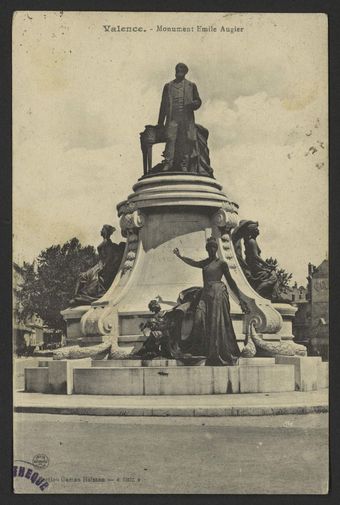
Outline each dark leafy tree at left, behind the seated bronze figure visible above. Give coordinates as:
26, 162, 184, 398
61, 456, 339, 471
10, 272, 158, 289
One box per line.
14, 238, 98, 333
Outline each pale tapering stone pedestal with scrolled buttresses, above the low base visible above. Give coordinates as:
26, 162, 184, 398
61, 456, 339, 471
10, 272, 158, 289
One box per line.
62, 173, 284, 352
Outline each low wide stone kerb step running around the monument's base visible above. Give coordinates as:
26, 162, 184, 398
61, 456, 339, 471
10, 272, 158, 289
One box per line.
14, 389, 328, 417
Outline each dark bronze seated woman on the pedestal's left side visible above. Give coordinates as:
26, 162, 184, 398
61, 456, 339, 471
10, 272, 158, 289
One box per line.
70, 224, 125, 306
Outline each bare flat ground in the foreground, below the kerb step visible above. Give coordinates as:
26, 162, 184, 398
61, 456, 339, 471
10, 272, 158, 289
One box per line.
14, 414, 328, 494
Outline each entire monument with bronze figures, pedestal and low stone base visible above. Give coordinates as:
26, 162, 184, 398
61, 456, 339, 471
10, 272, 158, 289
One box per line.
25, 64, 327, 395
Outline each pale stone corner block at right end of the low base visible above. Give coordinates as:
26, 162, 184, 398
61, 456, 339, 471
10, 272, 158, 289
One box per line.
275, 356, 322, 391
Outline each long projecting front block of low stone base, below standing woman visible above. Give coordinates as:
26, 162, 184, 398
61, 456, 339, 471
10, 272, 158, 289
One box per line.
74, 364, 295, 395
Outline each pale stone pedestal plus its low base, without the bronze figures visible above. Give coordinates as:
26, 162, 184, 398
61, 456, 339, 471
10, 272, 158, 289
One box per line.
20, 173, 308, 395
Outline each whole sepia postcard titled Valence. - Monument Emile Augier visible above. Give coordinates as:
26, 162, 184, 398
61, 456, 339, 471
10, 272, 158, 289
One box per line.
13, 11, 329, 495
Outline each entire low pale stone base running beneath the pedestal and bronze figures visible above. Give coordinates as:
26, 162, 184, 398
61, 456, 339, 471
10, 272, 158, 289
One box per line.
25, 356, 328, 396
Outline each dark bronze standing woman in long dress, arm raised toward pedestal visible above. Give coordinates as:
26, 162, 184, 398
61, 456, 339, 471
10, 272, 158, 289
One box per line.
174, 237, 248, 365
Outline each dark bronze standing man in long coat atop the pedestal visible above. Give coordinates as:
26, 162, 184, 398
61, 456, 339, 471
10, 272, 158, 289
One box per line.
158, 63, 202, 172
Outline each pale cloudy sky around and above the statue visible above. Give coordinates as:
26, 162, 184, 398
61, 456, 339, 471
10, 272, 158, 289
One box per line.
13, 12, 328, 284
